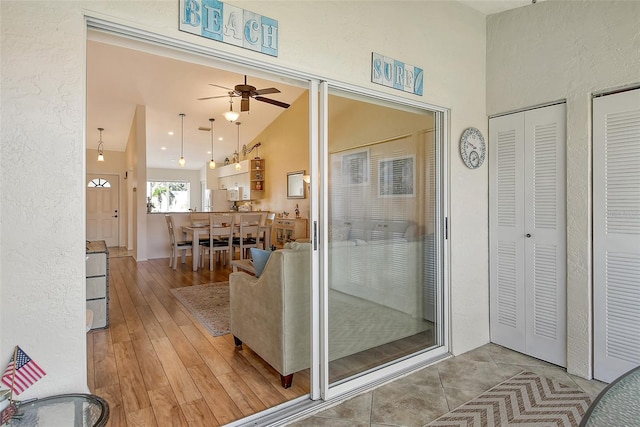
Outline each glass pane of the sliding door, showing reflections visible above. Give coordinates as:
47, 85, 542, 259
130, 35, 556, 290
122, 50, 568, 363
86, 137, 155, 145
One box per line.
325, 90, 443, 386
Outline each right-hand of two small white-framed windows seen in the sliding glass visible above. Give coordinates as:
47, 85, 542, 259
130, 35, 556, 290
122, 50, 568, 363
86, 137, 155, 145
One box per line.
378, 155, 416, 197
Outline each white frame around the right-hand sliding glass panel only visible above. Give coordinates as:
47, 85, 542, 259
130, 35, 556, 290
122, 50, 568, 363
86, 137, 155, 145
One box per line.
312, 81, 450, 400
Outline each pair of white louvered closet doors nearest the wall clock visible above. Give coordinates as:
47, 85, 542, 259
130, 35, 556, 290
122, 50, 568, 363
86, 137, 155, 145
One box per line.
489, 104, 566, 366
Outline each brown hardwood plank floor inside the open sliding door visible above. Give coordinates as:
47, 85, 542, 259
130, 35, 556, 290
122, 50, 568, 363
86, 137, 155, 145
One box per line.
87, 257, 309, 426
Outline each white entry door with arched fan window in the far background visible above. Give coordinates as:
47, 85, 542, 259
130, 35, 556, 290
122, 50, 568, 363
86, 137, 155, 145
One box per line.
87, 174, 120, 247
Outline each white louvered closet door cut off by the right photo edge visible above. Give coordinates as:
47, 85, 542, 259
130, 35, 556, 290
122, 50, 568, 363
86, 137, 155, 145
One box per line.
593, 89, 640, 382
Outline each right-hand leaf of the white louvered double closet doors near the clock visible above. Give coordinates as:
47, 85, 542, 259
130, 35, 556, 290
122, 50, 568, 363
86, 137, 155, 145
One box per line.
524, 104, 567, 366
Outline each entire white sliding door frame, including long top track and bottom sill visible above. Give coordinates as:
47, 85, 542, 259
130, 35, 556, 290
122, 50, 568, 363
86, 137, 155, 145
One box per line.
85, 14, 450, 425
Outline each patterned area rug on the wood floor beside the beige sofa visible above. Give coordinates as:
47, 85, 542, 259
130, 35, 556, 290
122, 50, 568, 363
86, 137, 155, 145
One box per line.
171, 282, 229, 337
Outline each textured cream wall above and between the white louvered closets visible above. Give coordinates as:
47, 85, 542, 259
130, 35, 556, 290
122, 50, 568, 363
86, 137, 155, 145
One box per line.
487, 0, 640, 378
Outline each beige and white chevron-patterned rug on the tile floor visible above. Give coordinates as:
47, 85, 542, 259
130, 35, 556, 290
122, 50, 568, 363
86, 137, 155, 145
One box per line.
427, 371, 591, 427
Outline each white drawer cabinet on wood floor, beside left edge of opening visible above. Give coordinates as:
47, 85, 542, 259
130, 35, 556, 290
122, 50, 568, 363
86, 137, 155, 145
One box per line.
86, 240, 109, 329
